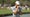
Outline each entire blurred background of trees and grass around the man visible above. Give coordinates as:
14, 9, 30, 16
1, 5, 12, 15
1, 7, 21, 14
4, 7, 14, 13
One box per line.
0, 0, 30, 16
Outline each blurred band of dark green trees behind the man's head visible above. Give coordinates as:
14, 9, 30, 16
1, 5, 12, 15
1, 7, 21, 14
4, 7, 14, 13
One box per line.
0, 0, 30, 6
